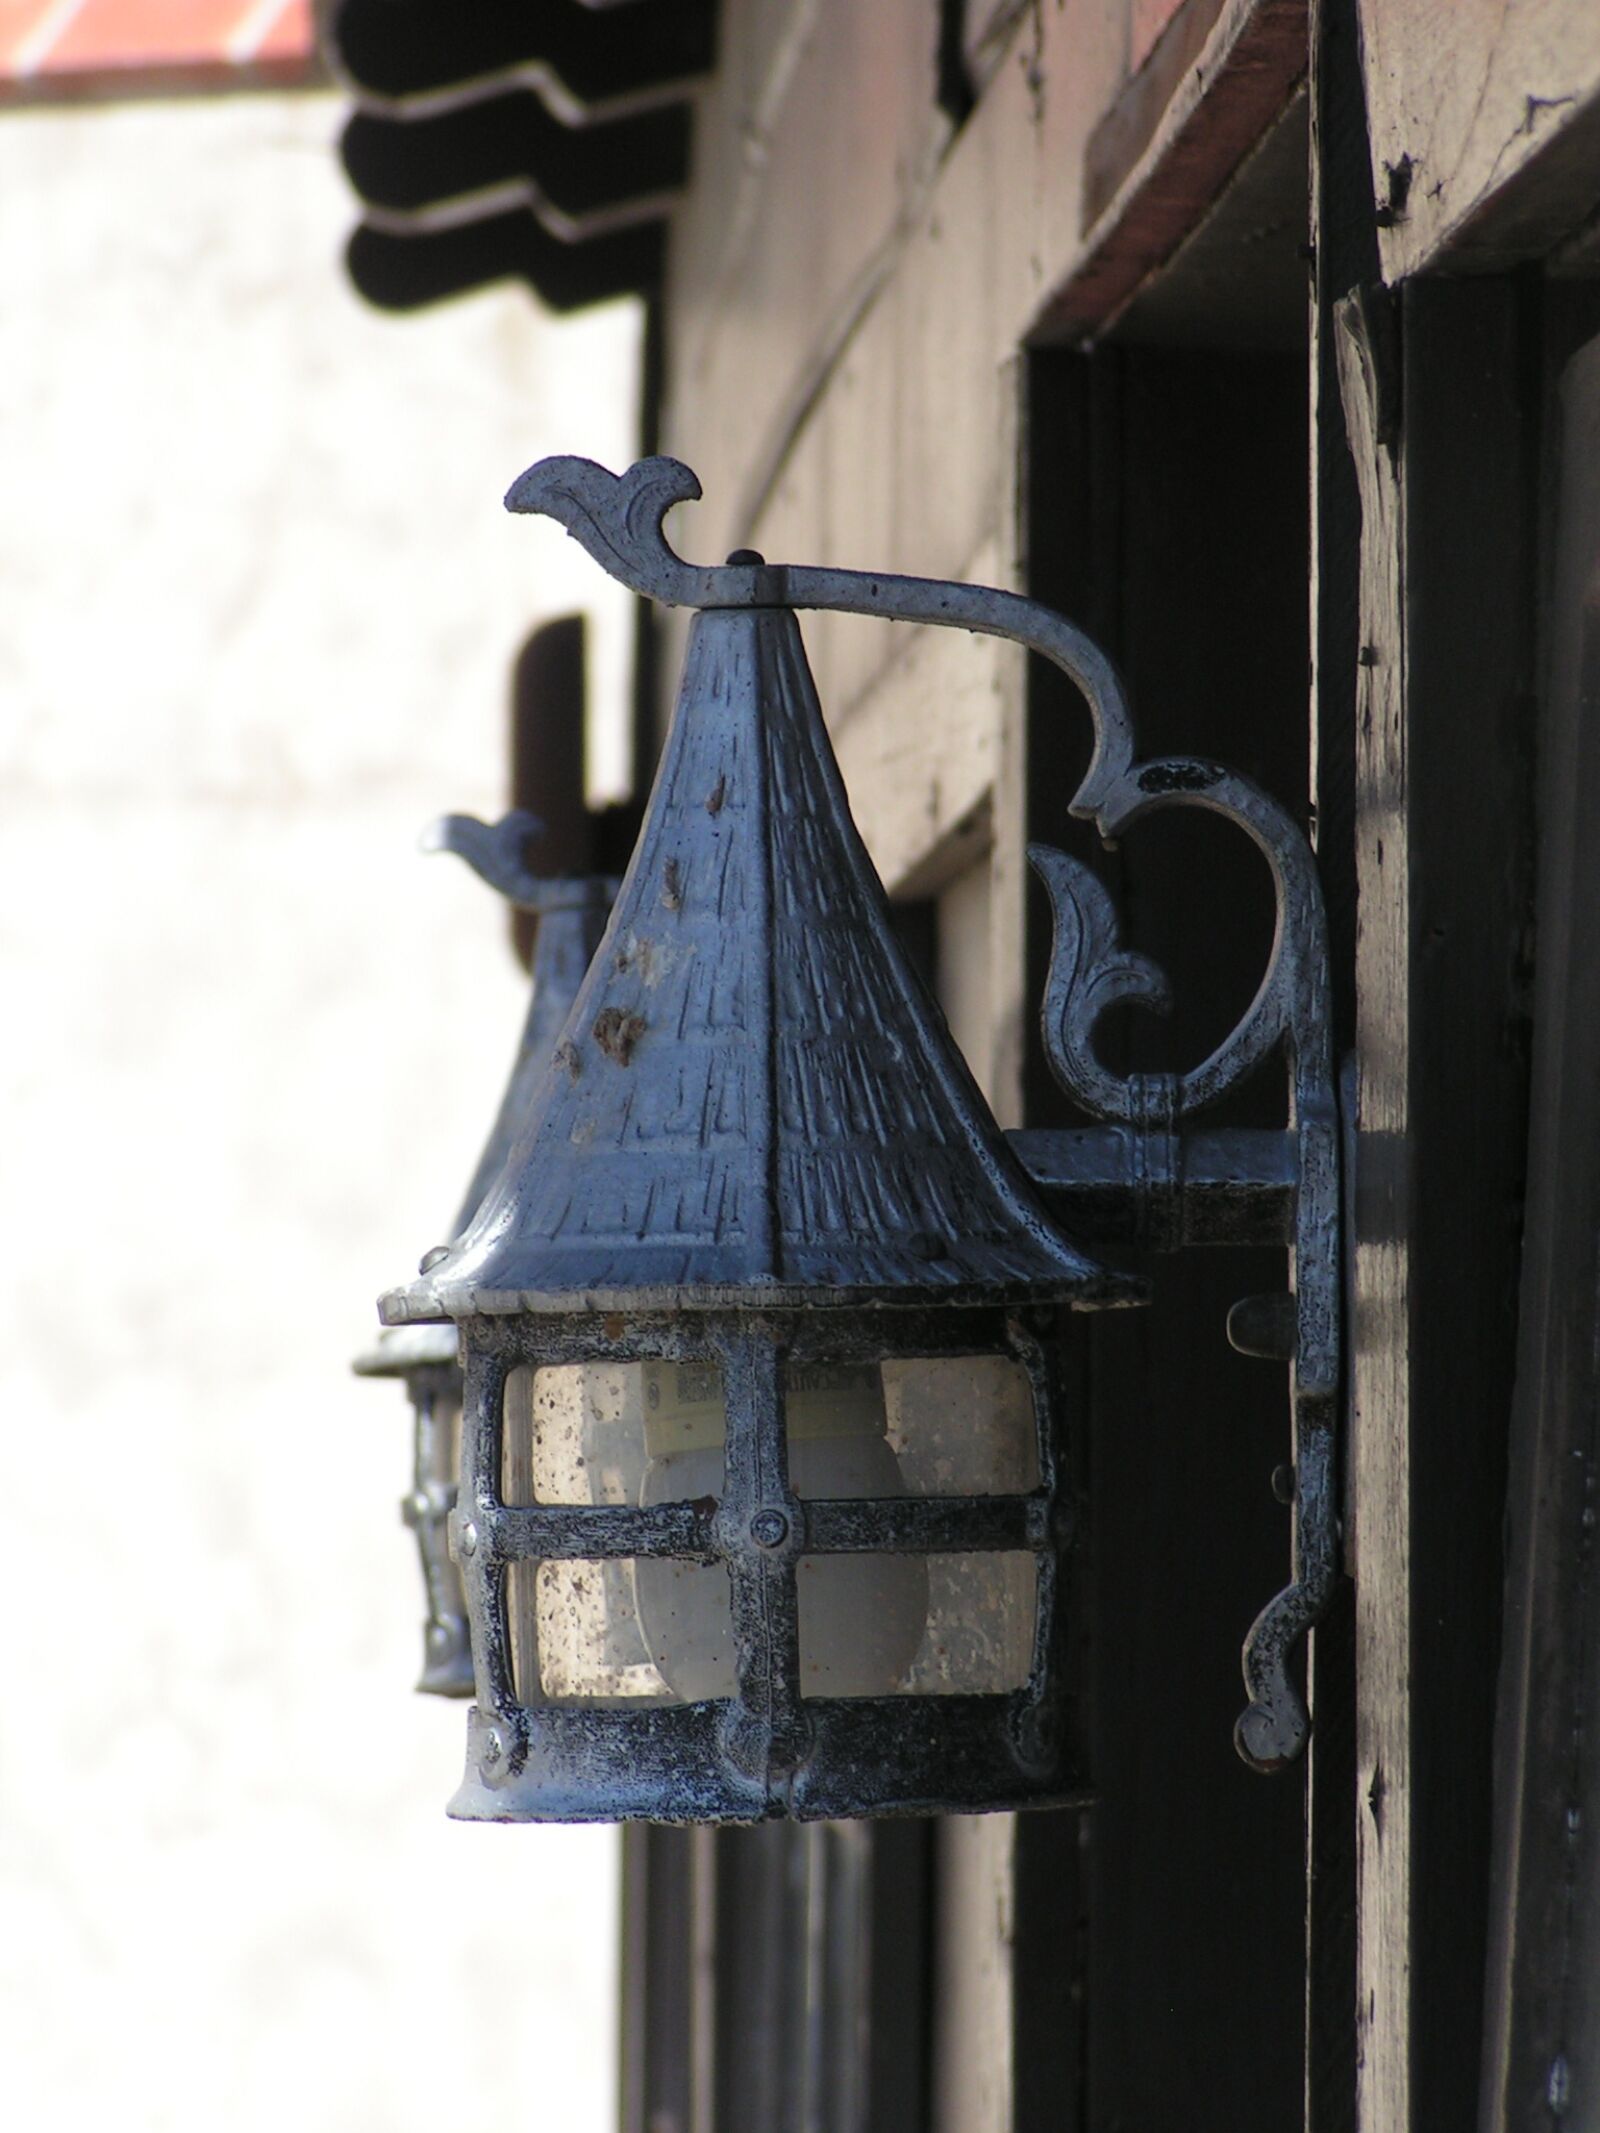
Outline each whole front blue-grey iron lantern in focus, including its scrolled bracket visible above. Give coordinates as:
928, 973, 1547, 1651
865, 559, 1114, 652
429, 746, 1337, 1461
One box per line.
382, 459, 1340, 1822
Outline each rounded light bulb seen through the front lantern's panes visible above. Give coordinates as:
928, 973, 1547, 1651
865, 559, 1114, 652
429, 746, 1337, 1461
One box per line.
634, 1363, 928, 1702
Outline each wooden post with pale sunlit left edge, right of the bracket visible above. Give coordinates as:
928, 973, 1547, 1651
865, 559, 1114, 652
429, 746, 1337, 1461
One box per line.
1342, 279, 1538, 2133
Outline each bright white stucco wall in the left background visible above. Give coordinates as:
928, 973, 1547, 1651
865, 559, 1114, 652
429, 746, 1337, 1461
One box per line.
0, 96, 634, 2133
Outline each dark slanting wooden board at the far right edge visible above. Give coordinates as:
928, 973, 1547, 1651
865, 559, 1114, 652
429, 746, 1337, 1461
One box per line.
1483, 324, 1600, 2133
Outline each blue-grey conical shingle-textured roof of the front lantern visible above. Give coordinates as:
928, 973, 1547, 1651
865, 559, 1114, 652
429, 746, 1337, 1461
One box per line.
382, 588, 1135, 1325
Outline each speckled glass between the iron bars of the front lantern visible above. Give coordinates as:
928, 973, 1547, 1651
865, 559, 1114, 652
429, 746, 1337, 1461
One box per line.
501, 1354, 1039, 1702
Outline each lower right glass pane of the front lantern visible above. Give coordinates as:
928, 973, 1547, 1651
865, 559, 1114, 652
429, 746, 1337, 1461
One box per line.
798, 1549, 1039, 1696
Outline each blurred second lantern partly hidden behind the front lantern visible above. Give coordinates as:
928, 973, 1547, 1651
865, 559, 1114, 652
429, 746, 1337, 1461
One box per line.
352, 808, 617, 1696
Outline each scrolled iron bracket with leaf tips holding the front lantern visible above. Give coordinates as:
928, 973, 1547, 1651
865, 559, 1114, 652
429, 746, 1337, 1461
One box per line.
506, 459, 1342, 1770
